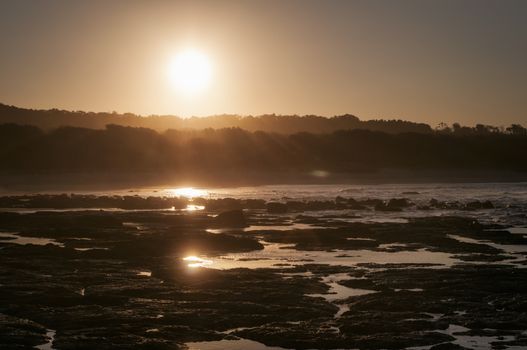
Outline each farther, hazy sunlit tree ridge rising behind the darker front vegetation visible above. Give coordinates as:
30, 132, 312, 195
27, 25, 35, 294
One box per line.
0, 104, 433, 134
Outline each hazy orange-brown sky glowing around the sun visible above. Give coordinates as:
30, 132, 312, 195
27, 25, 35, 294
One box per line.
0, 0, 527, 125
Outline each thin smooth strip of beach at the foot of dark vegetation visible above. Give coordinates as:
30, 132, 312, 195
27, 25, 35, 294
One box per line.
0, 169, 527, 194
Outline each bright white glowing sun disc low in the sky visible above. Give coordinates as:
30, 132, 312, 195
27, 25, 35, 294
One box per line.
168, 49, 212, 95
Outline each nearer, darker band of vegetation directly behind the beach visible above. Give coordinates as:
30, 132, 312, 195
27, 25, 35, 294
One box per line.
0, 124, 527, 174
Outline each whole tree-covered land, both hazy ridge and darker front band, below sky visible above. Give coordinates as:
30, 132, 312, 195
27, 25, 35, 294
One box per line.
0, 104, 527, 178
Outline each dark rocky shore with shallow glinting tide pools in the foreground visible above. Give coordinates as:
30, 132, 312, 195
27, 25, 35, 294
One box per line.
0, 195, 527, 350
